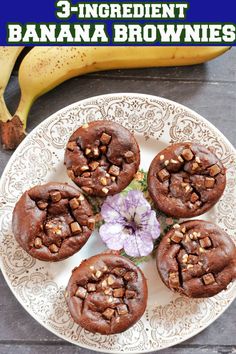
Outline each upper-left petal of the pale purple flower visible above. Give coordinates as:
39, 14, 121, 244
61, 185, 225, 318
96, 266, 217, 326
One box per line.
101, 194, 124, 223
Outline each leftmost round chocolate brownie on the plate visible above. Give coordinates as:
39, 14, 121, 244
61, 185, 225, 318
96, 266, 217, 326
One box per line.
12, 183, 95, 261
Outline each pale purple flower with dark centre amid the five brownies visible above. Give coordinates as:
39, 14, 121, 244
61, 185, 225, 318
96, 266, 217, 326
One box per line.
99, 190, 160, 257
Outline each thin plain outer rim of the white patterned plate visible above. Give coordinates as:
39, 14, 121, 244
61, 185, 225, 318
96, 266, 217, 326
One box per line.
0, 92, 236, 353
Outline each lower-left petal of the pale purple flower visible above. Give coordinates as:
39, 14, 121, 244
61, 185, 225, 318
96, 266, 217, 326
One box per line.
99, 223, 126, 251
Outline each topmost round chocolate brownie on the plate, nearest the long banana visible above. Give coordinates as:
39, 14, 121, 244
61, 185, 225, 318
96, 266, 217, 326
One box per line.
65, 120, 140, 197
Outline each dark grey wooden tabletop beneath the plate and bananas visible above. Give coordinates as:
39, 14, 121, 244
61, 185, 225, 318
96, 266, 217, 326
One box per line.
0, 48, 236, 354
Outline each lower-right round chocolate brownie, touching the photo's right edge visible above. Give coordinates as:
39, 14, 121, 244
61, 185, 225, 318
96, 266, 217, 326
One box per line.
156, 220, 236, 298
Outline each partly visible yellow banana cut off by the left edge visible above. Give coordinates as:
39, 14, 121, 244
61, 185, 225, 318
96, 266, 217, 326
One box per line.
0, 46, 24, 148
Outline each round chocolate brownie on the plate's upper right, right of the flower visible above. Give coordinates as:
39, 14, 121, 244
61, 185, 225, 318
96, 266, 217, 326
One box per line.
148, 142, 226, 218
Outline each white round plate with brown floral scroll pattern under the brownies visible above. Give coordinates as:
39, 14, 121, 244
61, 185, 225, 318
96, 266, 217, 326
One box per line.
0, 94, 236, 353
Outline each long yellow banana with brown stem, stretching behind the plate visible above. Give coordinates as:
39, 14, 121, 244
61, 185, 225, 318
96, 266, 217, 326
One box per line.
0, 46, 229, 149
